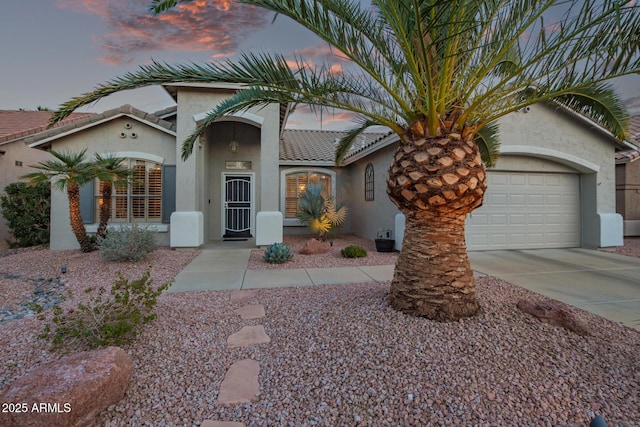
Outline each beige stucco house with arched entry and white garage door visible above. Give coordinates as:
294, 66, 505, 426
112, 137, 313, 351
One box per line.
17, 83, 632, 250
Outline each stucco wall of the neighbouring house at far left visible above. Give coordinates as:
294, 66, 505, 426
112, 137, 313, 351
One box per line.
0, 141, 49, 249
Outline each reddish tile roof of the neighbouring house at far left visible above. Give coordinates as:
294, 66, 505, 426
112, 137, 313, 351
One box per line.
0, 110, 94, 144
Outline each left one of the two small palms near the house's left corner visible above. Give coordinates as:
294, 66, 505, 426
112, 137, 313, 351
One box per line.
22, 149, 95, 252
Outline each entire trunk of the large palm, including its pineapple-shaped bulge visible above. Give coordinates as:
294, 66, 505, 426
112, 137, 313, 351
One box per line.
387, 132, 486, 321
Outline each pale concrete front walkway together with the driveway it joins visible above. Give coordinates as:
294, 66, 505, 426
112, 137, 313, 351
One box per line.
169, 245, 640, 329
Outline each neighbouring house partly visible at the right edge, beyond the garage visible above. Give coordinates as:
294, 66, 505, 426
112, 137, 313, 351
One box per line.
616, 116, 640, 236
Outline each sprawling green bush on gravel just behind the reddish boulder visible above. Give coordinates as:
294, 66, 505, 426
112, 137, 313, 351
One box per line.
39, 269, 172, 350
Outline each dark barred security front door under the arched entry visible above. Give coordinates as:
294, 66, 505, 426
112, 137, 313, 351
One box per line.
222, 173, 253, 239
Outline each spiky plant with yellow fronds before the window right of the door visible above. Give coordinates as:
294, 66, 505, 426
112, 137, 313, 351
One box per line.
296, 183, 347, 240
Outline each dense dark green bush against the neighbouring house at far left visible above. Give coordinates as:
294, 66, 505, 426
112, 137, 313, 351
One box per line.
0, 182, 51, 248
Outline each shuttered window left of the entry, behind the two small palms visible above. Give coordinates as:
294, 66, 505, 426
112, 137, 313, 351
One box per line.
94, 159, 162, 222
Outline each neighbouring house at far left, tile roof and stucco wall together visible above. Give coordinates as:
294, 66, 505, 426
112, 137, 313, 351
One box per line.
0, 110, 91, 249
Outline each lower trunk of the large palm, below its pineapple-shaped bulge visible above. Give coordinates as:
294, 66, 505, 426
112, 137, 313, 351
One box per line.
390, 212, 479, 321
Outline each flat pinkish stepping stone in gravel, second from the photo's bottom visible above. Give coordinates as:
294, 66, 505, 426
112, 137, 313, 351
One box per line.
216, 359, 260, 406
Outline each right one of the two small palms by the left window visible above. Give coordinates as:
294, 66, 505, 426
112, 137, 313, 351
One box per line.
93, 154, 131, 238
